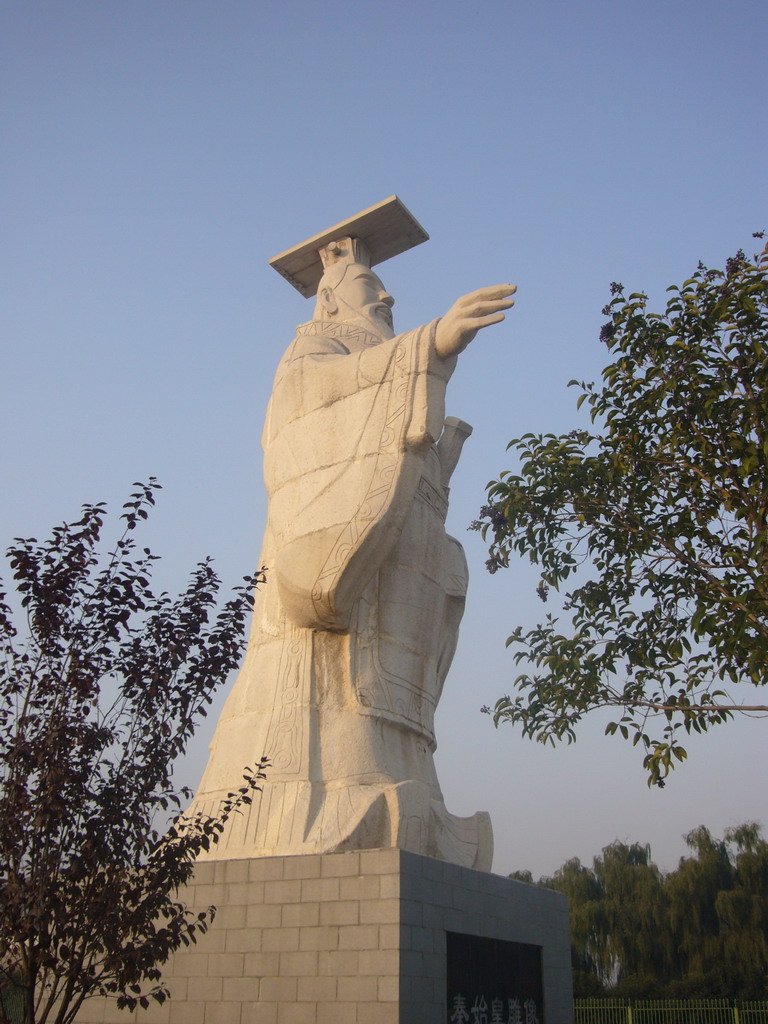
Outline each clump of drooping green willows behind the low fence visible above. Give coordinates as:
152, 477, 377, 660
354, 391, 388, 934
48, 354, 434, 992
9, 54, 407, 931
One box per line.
515, 823, 768, 999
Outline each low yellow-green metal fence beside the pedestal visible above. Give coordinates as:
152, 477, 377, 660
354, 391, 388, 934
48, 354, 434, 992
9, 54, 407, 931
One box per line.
573, 999, 768, 1024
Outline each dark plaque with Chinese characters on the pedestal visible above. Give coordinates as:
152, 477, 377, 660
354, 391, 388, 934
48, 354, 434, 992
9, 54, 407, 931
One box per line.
446, 932, 544, 1024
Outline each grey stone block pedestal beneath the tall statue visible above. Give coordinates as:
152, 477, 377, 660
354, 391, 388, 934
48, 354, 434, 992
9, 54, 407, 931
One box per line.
78, 849, 572, 1024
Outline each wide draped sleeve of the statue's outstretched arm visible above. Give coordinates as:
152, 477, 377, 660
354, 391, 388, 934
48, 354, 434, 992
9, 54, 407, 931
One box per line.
263, 322, 456, 632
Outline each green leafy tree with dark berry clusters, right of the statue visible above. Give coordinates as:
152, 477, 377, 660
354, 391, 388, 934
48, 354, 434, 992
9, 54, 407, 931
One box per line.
473, 236, 768, 785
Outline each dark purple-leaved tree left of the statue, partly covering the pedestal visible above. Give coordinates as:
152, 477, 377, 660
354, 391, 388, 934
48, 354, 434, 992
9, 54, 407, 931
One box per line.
0, 479, 263, 1024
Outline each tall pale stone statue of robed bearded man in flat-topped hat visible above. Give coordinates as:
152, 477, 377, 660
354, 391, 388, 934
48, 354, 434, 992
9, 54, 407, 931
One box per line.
191, 197, 515, 870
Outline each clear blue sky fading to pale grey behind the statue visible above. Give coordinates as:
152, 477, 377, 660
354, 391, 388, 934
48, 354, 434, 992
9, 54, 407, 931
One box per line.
0, 0, 768, 874
